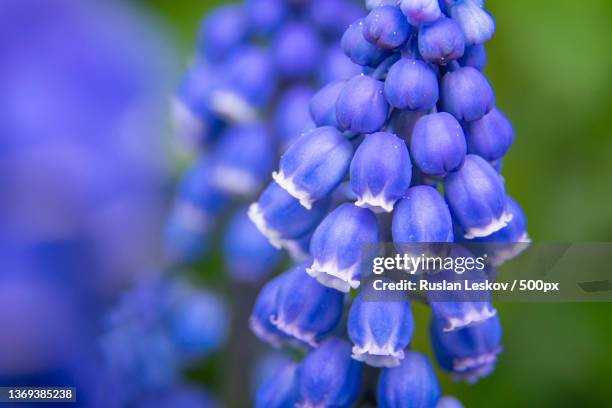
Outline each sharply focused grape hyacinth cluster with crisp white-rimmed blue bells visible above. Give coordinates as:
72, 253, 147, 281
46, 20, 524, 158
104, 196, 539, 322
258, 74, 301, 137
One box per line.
249, 0, 528, 407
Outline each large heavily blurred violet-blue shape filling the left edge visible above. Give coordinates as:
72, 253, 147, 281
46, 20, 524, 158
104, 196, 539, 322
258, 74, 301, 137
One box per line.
0, 0, 168, 407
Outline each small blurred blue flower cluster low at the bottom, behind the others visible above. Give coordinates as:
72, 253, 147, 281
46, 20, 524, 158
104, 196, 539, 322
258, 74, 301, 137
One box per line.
99, 277, 229, 407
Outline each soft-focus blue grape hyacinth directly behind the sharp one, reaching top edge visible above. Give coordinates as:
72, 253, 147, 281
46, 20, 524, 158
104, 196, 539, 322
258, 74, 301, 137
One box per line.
165, 0, 365, 283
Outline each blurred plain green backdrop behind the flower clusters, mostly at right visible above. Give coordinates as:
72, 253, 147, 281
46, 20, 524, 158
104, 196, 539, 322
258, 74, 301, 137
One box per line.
144, 0, 612, 407
